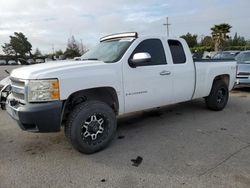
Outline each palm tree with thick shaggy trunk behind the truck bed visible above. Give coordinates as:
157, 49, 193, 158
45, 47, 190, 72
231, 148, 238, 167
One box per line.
211, 23, 232, 51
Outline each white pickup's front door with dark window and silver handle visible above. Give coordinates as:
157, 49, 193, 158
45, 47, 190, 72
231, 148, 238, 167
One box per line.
123, 38, 173, 112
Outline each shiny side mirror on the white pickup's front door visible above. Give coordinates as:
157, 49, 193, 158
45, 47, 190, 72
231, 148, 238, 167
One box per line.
129, 52, 151, 68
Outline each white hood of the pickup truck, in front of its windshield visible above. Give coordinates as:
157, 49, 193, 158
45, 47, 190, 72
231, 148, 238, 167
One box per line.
11, 60, 106, 79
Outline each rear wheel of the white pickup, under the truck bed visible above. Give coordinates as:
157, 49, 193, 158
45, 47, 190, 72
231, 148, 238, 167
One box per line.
205, 80, 229, 111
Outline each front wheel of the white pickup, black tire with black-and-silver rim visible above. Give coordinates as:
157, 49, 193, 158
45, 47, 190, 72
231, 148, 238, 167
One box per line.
65, 101, 117, 154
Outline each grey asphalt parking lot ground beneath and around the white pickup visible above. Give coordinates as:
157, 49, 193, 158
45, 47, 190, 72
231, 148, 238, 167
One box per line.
0, 90, 250, 188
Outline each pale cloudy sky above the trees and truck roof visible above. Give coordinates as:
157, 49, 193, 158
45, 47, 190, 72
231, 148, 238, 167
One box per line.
0, 0, 250, 53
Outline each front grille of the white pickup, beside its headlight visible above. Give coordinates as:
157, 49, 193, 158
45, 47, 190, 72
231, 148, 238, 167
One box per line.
10, 78, 25, 103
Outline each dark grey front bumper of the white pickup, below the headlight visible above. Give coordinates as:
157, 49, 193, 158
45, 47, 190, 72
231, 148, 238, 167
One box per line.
6, 97, 63, 133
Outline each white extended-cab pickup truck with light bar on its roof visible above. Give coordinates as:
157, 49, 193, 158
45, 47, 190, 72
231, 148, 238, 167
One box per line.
1, 33, 236, 153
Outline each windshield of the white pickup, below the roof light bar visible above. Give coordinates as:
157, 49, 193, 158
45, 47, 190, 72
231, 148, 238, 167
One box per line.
81, 38, 134, 63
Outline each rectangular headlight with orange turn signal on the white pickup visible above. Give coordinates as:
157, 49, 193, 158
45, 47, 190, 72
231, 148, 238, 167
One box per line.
28, 79, 60, 102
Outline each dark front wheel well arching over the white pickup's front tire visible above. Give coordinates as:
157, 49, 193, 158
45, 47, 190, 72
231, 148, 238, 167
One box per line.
62, 87, 119, 120
